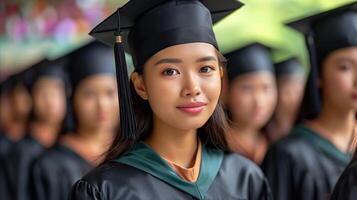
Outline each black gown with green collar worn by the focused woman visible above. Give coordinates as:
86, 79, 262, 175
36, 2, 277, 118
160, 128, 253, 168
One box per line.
70, 142, 271, 200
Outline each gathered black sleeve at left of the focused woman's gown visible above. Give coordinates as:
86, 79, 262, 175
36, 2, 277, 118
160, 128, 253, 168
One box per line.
69, 180, 105, 200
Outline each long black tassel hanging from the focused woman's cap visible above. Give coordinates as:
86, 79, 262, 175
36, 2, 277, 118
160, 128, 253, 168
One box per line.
114, 10, 137, 142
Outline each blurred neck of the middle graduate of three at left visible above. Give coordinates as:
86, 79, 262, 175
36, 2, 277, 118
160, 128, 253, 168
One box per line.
30, 121, 60, 147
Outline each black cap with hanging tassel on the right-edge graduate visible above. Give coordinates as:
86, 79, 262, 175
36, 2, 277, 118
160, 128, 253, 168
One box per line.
287, 1, 357, 119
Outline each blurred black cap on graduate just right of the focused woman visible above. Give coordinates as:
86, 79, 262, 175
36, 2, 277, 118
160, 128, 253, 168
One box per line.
225, 43, 274, 81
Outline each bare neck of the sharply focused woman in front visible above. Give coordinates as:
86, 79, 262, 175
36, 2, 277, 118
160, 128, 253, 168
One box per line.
145, 116, 198, 167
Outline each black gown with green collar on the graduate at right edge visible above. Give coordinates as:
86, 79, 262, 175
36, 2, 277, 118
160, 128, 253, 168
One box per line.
262, 125, 351, 200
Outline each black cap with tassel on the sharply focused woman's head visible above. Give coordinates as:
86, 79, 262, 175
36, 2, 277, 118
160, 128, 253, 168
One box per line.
90, 0, 242, 142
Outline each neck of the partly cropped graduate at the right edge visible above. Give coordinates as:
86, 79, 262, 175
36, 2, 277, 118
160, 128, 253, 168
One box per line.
310, 101, 355, 152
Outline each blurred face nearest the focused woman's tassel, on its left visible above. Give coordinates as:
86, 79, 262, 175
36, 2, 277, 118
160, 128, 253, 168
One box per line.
73, 74, 119, 131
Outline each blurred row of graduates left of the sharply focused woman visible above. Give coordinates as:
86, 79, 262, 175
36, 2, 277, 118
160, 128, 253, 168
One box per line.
0, 42, 119, 200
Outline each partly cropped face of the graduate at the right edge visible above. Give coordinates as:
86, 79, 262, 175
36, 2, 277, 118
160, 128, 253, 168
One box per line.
320, 47, 357, 110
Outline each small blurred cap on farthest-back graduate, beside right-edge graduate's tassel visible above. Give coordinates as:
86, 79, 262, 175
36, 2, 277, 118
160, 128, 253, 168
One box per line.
275, 57, 303, 78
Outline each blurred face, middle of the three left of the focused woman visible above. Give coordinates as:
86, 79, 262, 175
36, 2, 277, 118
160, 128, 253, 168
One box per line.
32, 77, 66, 124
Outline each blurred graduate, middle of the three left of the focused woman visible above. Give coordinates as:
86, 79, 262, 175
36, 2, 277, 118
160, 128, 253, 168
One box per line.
6, 60, 66, 199
